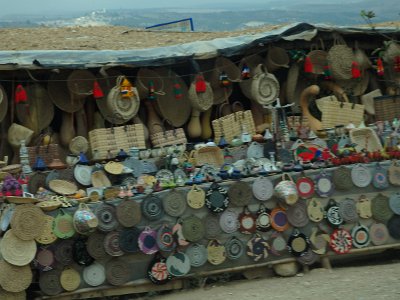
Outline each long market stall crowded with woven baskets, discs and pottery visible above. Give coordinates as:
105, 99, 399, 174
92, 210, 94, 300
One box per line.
0, 24, 400, 299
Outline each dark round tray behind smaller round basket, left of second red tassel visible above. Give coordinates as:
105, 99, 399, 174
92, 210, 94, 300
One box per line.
47, 72, 86, 113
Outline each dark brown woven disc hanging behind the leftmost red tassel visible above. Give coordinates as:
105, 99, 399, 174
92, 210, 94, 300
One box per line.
15, 84, 54, 134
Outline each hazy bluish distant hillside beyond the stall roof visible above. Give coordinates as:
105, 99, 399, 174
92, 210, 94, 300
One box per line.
0, 0, 400, 31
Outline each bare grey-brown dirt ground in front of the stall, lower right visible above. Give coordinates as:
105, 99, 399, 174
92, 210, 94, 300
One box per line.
151, 255, 400, 300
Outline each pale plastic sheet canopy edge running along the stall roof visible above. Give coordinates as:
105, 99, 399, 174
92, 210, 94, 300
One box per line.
0, 23, 399, 70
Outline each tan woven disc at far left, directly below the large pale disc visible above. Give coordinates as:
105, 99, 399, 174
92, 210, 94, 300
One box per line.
0, 260, 33, 293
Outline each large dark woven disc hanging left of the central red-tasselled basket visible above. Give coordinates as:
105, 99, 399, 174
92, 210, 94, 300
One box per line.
152, 68, 192, 127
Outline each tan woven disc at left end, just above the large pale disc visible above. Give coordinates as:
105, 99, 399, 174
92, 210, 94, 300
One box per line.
11, 204, 45, 240
